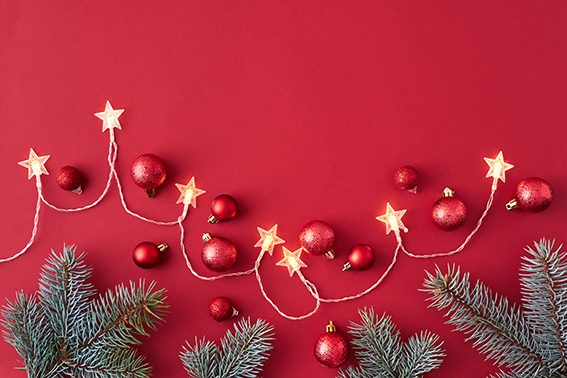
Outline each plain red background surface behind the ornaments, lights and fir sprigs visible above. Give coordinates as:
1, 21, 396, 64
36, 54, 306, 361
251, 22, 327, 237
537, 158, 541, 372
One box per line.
0, 1, 567, 378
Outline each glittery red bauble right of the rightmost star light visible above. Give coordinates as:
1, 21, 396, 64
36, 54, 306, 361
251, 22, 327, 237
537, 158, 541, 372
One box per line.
506, 177, 553, 213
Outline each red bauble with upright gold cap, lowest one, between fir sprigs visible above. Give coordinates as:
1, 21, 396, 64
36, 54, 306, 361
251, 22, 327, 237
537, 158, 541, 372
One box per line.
315, 322, 348, 368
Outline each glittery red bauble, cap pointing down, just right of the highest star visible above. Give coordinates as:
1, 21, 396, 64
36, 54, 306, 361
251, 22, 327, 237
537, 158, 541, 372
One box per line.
130, 154, 167, 198
